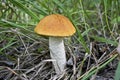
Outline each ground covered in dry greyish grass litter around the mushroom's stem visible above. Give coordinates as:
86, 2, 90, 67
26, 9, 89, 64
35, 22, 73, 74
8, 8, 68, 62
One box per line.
0, 28, 118, 80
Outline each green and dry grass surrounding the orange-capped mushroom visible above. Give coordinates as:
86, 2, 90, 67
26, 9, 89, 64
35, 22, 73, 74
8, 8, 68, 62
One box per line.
0, 0, 120, 80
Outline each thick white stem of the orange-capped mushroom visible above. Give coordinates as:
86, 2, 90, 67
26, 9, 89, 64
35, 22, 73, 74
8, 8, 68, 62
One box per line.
49, 37, 66, 74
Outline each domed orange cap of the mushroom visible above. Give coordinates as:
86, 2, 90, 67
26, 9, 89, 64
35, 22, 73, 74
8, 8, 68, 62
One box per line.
34, 14, 76, 37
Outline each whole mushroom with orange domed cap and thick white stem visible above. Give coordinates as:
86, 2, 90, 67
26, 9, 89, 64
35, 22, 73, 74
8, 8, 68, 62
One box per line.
34, 14, 76, 74
